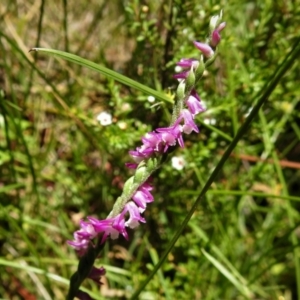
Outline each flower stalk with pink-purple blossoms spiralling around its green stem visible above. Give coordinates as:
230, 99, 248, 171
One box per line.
68, 13, 225, 299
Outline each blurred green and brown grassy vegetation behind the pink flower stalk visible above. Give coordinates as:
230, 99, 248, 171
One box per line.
0, 0, 300, 300
